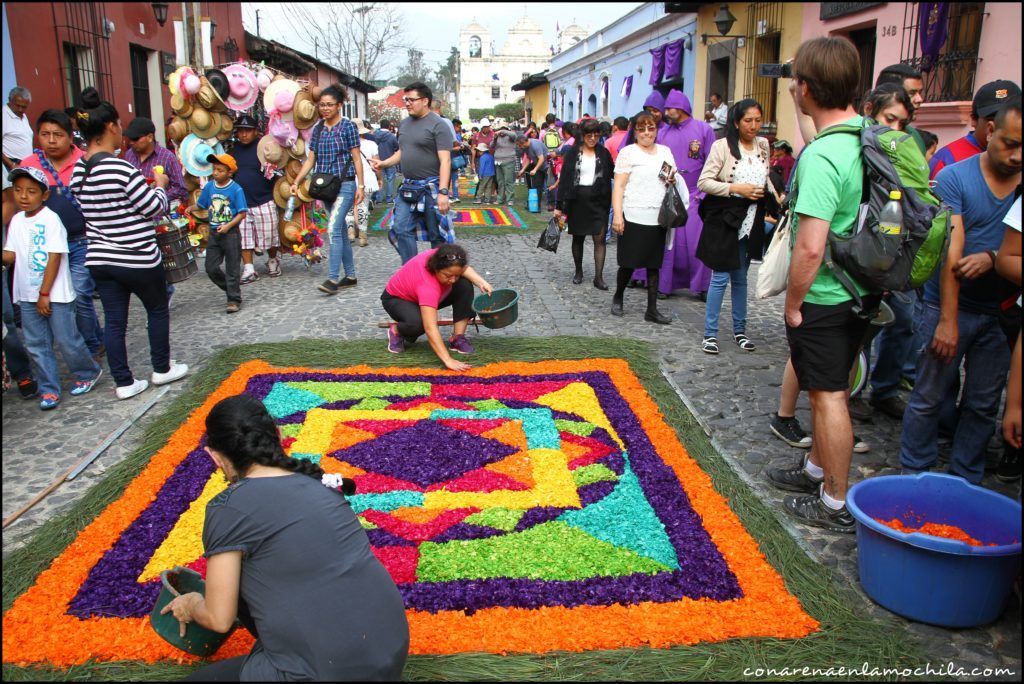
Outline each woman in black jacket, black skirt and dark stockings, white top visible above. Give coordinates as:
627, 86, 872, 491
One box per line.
555, 119, 614, 290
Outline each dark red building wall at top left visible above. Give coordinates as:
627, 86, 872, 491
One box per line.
5, 2, 248, 128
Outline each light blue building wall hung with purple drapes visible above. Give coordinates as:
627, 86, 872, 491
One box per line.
548, 2, 697, 121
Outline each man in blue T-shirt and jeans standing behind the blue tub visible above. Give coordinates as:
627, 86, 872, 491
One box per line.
900, 97, 1021, 484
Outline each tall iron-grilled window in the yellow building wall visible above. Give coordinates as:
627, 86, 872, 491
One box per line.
745, 2, 783, 135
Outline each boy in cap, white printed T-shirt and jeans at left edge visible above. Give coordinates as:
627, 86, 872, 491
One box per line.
3, 167, 102, 411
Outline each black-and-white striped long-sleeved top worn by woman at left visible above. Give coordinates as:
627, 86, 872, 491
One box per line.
71, 157, 168, 268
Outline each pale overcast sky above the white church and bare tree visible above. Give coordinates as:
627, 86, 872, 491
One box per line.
242, 2, 642, 76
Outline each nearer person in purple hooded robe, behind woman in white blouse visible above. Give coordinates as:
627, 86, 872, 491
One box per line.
656, 90, 715, 299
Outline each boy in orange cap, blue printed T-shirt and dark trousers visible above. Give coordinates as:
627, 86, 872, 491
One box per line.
188, 155, 249, 313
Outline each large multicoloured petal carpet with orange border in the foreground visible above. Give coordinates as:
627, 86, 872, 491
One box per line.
3, 359, 817, 667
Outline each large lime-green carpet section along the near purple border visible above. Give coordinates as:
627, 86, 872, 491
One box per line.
416, 520, 669, 583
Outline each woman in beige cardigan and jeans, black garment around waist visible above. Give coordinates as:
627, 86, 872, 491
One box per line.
696, 99, 778, 354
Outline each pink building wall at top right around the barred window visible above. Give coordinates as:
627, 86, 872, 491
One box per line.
794, 2, 1021, 152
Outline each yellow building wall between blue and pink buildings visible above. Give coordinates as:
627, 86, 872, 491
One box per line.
693, 2, 802, 148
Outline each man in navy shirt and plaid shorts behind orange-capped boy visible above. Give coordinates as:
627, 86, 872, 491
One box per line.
231, 114, 281, 285
